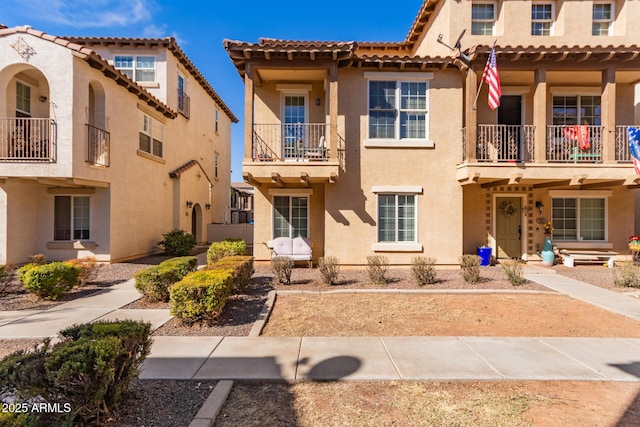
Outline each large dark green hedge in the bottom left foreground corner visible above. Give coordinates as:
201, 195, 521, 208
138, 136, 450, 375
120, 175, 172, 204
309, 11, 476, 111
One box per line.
0, 321, 151, 426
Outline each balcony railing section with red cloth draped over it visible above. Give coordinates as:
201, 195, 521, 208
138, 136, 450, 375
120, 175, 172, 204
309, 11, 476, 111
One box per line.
547, 125, 602, 163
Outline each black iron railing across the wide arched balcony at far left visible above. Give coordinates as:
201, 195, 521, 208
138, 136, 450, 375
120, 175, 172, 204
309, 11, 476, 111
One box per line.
0, 117, 57, 162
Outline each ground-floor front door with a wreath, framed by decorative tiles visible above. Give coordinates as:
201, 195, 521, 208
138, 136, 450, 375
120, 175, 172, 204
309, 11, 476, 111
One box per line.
496, 197, 522, 258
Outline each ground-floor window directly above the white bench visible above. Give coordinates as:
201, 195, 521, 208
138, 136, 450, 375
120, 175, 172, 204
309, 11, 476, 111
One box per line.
273, 196, 309, 239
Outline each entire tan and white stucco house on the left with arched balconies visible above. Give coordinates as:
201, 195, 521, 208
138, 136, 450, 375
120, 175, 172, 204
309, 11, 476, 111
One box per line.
0, 27, 237, 264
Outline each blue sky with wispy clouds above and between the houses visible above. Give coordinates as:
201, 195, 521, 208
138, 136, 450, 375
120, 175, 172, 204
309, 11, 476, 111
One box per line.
0, 0, 422, 181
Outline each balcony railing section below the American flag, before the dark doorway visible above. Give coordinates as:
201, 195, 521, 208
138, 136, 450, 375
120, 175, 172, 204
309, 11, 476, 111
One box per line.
476, 125, 535, 163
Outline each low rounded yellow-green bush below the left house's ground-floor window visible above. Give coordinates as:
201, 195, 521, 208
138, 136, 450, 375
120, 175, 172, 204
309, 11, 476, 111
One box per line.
19, 262, 81, 300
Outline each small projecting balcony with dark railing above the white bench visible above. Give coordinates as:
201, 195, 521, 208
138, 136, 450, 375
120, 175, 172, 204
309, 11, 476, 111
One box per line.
243, 123, 344, 185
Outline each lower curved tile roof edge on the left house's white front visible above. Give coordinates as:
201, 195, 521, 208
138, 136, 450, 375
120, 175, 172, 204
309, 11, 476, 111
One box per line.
0, 26, 177, 118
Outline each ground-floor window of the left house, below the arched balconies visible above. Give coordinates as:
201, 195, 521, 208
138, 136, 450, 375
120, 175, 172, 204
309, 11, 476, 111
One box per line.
53, 196, 91, 240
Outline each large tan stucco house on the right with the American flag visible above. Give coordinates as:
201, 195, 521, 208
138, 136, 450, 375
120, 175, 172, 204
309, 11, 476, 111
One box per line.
224, 0, 640, 264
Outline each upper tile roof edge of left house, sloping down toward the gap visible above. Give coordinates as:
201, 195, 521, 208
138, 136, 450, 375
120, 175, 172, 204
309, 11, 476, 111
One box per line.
66, 37, 238, 123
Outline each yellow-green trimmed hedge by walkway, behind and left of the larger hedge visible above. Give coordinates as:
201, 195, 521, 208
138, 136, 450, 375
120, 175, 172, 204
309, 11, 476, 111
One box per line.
133, 256, 198, 302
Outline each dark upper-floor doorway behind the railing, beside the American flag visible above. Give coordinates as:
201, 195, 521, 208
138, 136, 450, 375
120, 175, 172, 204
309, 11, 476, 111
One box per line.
496, 95, 523, 162
